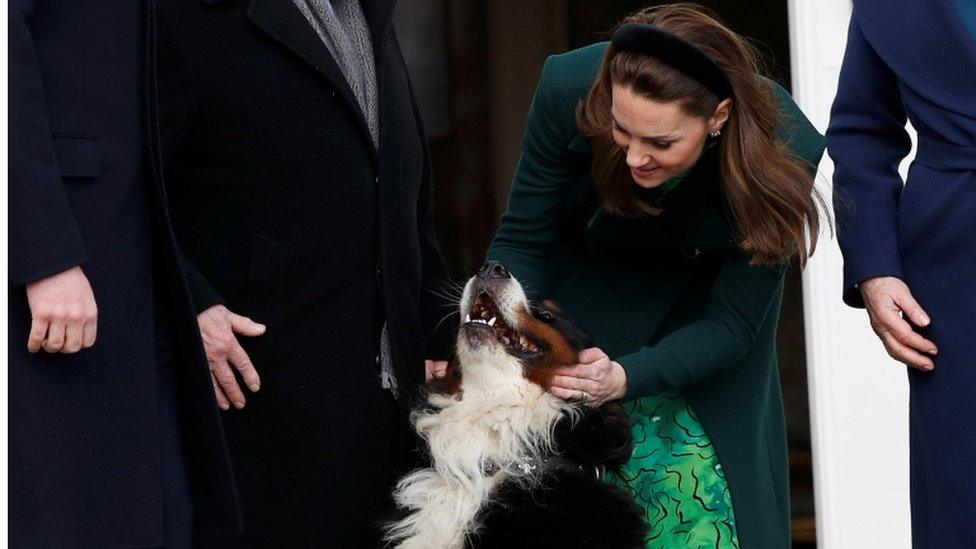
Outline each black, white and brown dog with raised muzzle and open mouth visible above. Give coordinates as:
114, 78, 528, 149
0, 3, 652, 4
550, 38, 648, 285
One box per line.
386, 262, 647, 549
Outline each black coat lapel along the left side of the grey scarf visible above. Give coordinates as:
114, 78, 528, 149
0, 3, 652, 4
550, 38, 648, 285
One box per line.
247, 0, 380, 152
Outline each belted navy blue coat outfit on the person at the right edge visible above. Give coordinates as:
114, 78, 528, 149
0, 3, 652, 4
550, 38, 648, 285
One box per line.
827, 0, 976, 549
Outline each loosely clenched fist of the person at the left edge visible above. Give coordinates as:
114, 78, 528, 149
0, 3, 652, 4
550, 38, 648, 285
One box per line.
27, 267, 98, 354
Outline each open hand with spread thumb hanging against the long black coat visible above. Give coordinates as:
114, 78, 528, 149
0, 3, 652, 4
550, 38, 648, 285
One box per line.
197, 305, 265, 410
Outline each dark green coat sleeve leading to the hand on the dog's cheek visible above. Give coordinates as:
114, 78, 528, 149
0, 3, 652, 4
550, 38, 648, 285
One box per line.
617, 252, 787, 399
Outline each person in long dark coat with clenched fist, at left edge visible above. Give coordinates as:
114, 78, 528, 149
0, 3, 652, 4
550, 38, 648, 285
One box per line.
8, 0, 240, 549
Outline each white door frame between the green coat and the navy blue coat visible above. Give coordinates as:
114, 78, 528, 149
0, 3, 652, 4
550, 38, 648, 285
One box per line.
788, 0, 911, 549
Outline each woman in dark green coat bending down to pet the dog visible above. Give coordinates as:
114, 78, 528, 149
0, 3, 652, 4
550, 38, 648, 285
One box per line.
488, 4, 824, 549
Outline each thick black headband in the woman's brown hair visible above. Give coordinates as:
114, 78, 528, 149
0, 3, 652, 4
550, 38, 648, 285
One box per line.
611, 23, 732, 99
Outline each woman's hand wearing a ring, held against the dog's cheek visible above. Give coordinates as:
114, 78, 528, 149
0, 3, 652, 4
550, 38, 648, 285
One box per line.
550, 347, 627, 407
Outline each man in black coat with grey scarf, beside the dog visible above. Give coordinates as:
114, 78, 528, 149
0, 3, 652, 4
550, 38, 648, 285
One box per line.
159, 0, 451, 547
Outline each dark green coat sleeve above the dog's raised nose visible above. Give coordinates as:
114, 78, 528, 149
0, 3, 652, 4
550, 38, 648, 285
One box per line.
487, 57, 575, 299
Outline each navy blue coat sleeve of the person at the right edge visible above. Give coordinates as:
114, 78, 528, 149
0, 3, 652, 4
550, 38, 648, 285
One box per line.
827, 14, 911, 307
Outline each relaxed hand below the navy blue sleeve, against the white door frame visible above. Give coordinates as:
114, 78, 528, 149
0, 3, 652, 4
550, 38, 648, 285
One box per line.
858, 276, 938, 372
